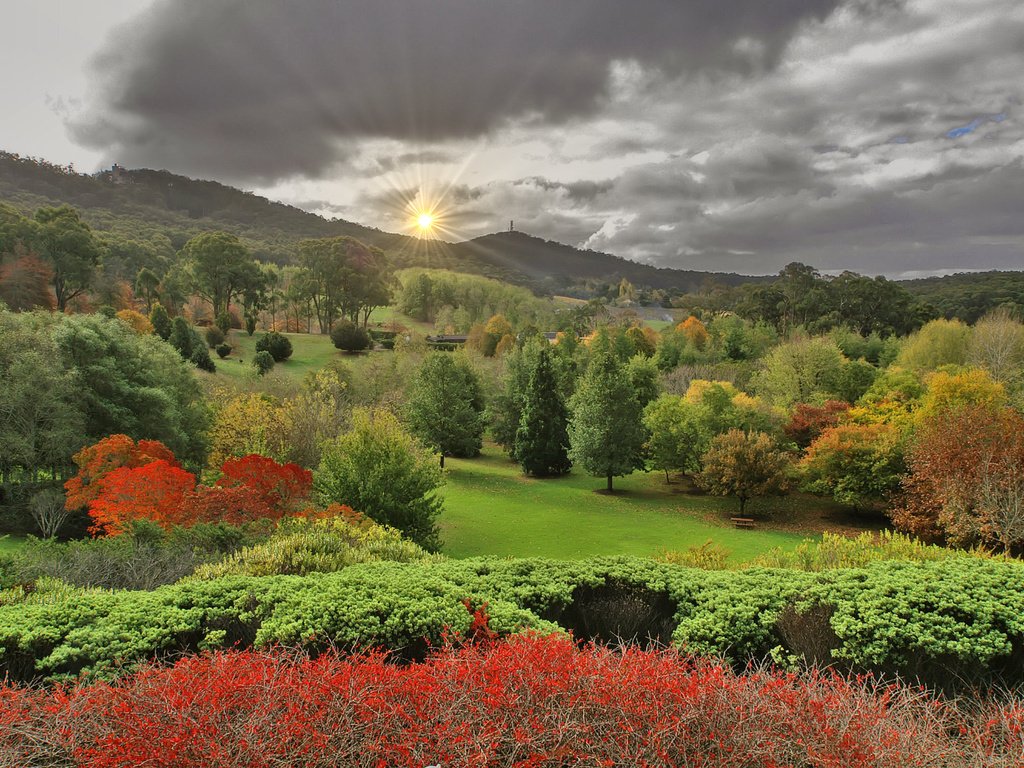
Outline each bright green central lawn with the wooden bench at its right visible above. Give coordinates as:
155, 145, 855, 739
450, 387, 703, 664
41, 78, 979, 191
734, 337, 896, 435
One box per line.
440, 446, 807, 561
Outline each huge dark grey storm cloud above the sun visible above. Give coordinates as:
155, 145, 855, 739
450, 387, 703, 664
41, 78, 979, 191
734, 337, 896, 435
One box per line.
70, 0, 840, 180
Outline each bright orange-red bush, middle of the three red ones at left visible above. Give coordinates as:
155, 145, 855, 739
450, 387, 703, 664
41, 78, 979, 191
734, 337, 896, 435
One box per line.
89, 459, 196, 536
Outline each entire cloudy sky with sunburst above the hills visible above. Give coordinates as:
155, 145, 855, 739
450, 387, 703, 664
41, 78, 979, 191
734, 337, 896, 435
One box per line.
0, 0, 1024, 276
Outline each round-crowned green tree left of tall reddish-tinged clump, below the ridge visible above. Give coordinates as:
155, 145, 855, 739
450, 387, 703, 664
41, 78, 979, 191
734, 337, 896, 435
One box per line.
180, 232, 260, 316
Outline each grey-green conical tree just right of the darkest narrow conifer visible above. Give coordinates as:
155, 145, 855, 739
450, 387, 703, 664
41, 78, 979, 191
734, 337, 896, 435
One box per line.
568, 351, 645, 494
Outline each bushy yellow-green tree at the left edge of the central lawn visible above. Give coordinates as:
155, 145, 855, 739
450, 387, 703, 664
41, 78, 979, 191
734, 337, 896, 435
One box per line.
313, 409, 443, 552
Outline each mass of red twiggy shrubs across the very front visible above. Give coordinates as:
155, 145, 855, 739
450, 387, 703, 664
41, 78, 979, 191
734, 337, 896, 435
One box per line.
0, 636, 1024, 768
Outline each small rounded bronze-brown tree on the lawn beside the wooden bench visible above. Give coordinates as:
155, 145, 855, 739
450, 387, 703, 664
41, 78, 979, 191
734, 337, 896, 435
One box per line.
694, 429, 790, 514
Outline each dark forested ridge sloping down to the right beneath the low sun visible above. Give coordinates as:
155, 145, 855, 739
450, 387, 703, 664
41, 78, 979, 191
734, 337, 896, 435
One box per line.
0, 152, 763, 291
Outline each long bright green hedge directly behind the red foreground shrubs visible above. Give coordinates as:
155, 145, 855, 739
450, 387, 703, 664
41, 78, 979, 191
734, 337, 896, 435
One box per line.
0, 558, 1024, 685
